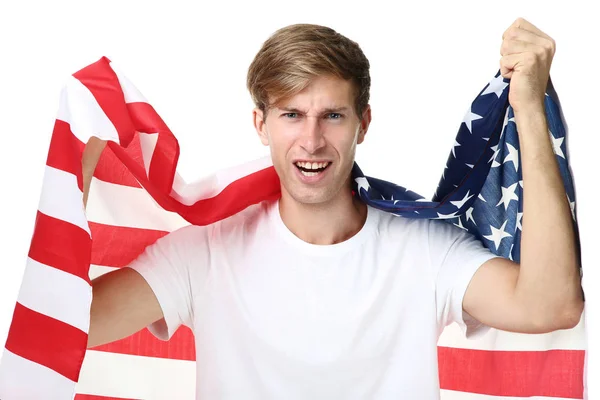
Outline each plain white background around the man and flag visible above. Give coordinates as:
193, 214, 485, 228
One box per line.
0, 0, 600, 398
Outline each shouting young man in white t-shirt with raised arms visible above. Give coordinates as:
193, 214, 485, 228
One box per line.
87, 19, 583, 399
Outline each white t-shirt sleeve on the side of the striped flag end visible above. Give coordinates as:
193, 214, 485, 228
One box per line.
127, 225, 210, 340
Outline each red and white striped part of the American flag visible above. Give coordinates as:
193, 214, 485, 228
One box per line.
0, 58, 585, 400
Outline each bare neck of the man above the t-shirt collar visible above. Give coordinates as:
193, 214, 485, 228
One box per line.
279, 191, 367, 245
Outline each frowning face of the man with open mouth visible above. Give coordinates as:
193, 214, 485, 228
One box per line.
254, 76, 371, 204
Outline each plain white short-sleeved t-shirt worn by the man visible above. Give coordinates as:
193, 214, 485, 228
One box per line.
130, 201, 495, 400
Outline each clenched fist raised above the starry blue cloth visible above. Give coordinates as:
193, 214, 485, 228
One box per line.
500, 18, 556, 114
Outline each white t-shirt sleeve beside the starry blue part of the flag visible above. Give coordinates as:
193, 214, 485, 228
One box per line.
428, 220, 499, 338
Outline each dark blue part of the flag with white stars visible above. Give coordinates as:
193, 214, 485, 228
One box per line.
352, 71, 579, 262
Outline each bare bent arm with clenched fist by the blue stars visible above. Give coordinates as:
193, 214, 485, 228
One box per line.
463, 19, 583, 333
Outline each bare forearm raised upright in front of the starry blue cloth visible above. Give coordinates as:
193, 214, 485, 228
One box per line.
515, 105, 583, 324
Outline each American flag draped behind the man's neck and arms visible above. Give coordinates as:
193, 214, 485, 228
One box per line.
0, 58, 585, 400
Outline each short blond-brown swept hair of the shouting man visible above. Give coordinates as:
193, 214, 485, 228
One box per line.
246, 24, 371, 119
